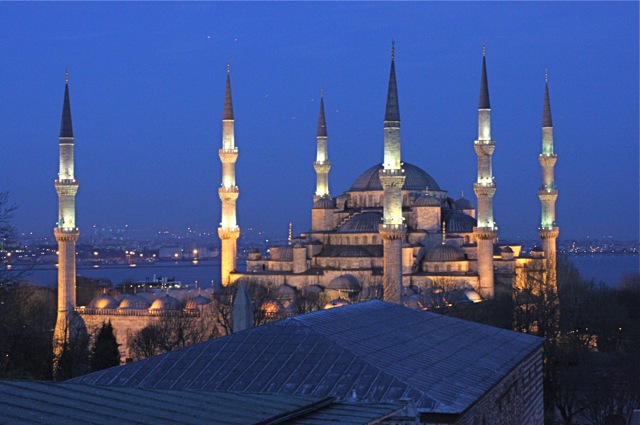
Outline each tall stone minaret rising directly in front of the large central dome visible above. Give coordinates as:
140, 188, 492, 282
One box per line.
379, 41, 406, 304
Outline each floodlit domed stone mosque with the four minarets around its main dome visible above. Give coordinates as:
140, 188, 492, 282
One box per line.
221, 49, 559, 308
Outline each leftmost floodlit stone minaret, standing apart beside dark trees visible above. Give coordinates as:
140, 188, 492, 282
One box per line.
53, 71, 80, 362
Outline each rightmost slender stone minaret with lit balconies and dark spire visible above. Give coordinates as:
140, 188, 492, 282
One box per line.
538, 73, 560, 285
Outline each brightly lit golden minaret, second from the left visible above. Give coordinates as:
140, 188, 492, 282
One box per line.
218, 65, 240, 286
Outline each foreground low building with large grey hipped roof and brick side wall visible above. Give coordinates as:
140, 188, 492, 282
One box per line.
69, 300, 543, 424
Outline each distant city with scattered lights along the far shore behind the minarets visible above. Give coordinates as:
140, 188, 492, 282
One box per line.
0, 225, 640, 264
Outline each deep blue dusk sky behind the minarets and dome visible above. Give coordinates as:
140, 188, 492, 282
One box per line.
0, 2, 639, 241
